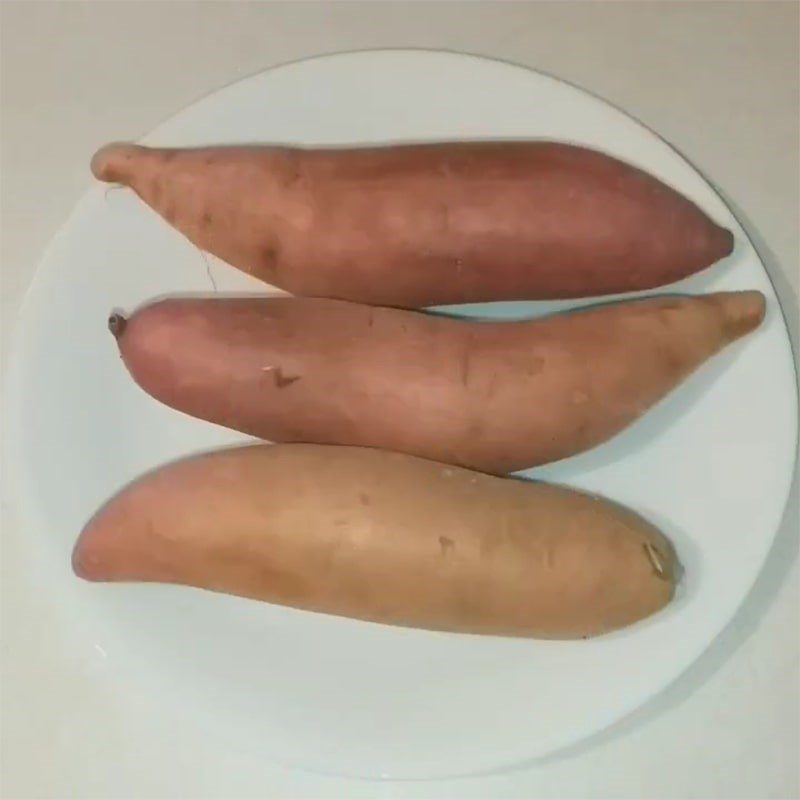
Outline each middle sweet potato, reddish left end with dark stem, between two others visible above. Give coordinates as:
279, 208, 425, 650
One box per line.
111, 292, 764, 473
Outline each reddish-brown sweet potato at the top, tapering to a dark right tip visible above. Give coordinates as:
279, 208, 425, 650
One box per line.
92, 142, 733, 307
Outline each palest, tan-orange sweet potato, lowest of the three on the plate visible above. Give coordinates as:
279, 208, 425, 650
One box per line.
73, 445, 677, 638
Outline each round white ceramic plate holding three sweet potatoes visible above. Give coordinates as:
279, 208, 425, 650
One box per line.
7, 51, 796, 777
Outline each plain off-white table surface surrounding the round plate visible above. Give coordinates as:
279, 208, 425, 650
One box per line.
0, 0, 800, 800
